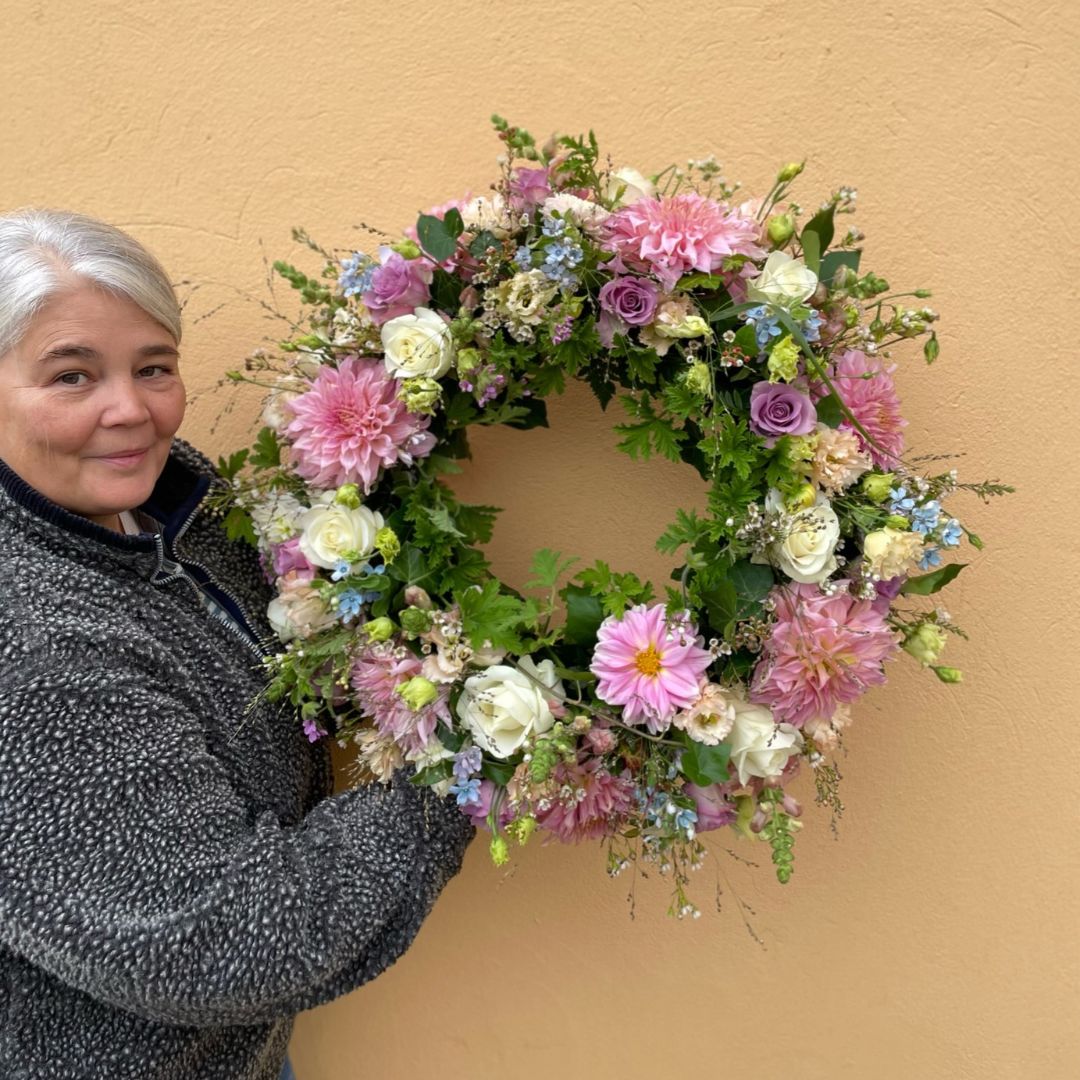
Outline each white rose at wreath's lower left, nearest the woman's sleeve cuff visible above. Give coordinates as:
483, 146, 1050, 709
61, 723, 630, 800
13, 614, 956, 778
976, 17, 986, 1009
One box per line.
457, 657, 563, 758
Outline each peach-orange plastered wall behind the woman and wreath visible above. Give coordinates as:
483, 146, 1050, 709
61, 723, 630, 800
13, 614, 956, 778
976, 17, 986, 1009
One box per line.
0, 0, 1080, 1080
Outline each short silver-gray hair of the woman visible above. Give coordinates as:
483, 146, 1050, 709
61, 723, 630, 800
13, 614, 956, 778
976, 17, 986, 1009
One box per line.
0, 210, 180, 355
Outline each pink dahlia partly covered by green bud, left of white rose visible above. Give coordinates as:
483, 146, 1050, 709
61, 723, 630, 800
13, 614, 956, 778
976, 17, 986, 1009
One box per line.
349, 640, 450, 751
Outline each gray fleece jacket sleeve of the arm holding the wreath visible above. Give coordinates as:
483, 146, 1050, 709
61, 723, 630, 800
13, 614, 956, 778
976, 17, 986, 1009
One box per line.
0, 669, 473, 1026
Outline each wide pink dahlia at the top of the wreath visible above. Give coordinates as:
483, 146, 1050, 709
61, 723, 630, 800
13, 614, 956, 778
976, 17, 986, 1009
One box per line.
602, 191, 766, 289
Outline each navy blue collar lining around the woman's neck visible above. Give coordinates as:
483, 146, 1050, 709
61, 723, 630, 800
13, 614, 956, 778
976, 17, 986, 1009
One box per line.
0, 442, 211, 553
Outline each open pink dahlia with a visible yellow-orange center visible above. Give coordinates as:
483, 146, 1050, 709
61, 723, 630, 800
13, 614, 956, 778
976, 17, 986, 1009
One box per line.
590, 604, 713, 732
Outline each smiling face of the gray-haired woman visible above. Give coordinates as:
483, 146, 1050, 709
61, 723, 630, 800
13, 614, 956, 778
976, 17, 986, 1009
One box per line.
0, 283, 185, 529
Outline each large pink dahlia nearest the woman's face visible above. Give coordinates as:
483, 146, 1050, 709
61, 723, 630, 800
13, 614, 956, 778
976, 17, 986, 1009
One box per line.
285, 356, 435, 492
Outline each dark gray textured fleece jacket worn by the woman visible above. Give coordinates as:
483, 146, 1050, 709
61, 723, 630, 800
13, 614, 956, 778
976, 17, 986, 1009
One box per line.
0, 441, 472, 1080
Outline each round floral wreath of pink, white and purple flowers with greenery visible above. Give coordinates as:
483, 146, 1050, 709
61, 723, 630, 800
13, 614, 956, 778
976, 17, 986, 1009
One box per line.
220, 117, 1010, 916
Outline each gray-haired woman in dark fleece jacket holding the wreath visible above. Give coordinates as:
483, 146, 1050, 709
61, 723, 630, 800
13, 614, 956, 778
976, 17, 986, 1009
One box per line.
0, 211, 472, 1080
